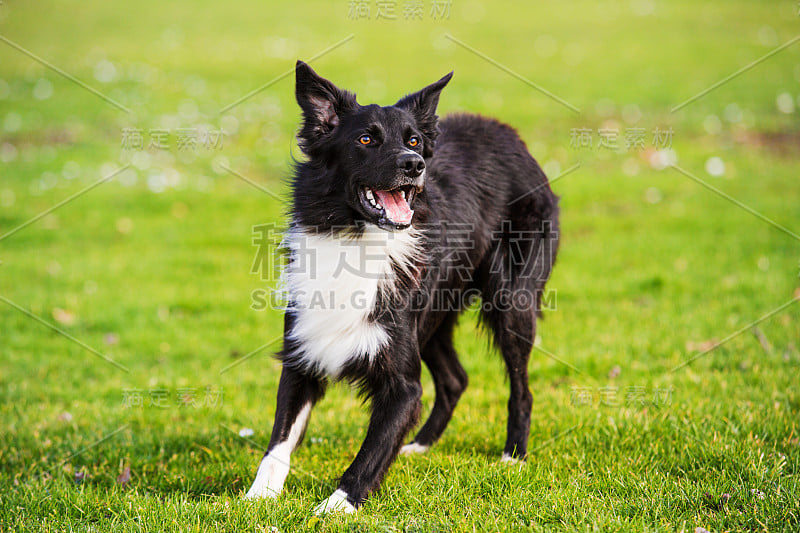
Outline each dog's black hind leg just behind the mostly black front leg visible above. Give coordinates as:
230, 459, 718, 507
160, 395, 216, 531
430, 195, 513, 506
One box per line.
400, 315, 468, 454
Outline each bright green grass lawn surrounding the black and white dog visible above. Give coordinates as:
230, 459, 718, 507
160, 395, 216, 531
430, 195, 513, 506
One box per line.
0, 0, 800, 532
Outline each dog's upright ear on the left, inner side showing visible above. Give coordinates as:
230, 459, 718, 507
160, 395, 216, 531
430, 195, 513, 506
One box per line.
295, 61, 358, 151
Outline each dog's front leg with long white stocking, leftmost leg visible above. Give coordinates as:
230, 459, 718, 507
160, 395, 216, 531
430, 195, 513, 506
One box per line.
245, 365, 325, 499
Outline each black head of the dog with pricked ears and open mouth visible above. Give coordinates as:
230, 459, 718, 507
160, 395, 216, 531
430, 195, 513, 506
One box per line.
295, 61, 453, 230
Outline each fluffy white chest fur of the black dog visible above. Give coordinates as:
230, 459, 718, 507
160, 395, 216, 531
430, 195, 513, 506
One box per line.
284, 225, 419, 377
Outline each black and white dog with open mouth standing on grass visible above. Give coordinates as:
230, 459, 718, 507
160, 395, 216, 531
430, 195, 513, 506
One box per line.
246, 61, 558, 514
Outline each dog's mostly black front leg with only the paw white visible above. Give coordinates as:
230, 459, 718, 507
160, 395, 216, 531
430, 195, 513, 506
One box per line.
316, 366, 422, 514
